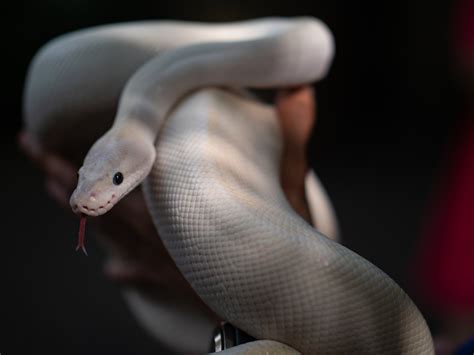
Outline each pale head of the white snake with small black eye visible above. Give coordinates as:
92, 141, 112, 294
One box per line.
69, 130, 156, 216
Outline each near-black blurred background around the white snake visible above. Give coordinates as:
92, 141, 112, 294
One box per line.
0, 0, 462, 355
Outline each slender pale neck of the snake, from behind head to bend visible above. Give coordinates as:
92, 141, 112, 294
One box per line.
111, 18, 334, 139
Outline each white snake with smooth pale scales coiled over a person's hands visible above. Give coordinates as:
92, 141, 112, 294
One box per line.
25, 18, 433, 354
